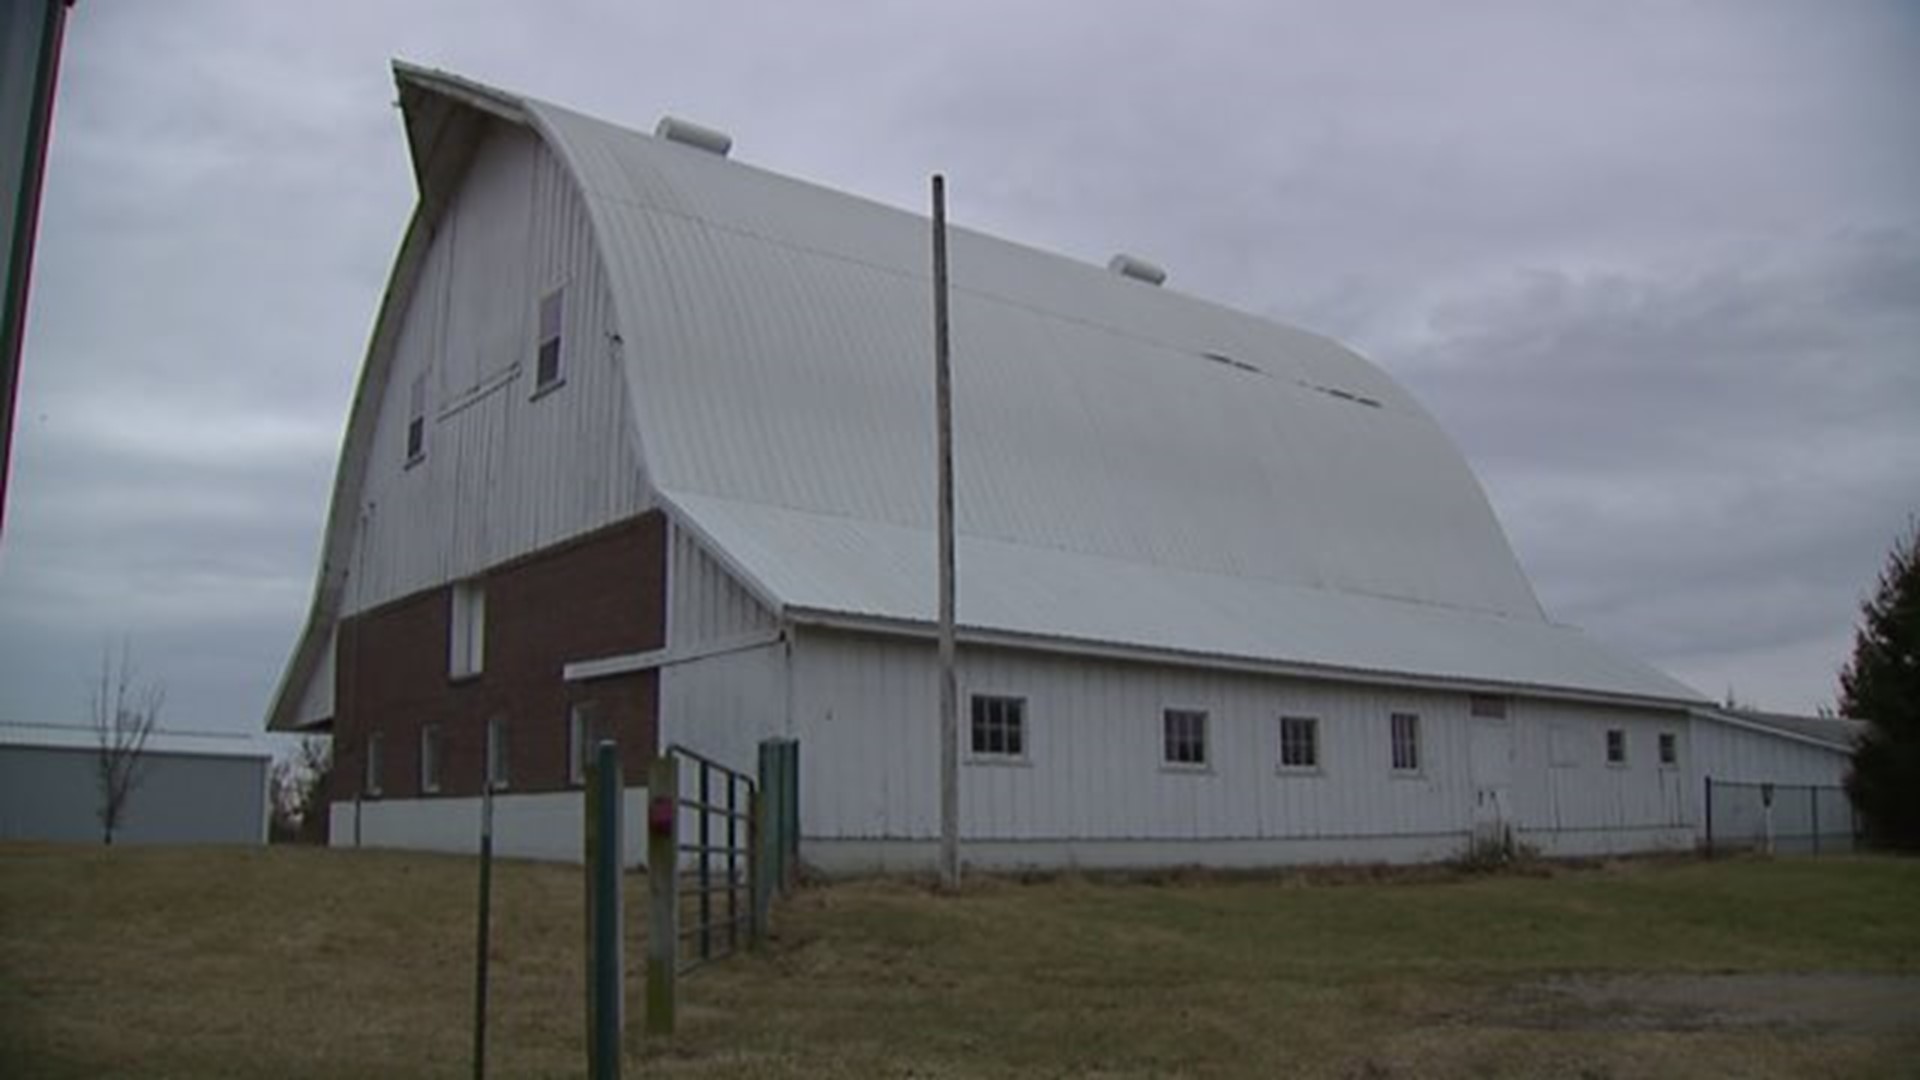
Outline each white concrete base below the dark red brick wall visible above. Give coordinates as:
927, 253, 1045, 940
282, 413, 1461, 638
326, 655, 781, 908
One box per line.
330, 788, 647, 867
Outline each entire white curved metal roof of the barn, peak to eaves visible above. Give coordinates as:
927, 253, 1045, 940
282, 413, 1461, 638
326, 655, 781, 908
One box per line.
266, 65, 1697, 726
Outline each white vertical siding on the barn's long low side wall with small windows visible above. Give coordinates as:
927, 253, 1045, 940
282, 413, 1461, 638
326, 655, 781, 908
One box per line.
793, 630, 1686, 846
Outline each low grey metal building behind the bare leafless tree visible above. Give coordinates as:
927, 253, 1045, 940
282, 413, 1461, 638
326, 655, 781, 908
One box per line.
0, 724, 273, 844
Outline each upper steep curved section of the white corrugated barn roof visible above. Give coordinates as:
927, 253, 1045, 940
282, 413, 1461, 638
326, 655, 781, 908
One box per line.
530, 95, 1540, 619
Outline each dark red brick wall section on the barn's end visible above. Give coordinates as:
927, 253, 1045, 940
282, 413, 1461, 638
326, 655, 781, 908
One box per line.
332, 511, 666, 799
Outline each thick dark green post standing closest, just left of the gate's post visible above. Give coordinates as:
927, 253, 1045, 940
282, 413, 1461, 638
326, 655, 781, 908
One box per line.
586, 742, 626, 1080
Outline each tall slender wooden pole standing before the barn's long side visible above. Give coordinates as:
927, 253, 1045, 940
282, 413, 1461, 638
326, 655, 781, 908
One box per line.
933, 175, 960, 890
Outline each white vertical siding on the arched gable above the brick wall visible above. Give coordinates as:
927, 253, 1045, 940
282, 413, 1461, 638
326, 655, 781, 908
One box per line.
344, 127, 647, 613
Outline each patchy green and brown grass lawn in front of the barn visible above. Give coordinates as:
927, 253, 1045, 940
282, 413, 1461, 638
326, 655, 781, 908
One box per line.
0, 846, 1920, 1078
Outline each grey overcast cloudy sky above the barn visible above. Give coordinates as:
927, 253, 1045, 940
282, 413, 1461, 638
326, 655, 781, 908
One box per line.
0, 0, 1920, 730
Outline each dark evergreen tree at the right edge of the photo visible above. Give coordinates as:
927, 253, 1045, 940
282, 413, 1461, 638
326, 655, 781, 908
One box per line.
1839, 519, 1920, 851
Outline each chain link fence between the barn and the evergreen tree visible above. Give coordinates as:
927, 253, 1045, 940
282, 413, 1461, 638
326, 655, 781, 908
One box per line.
1705, 776, 1860, 855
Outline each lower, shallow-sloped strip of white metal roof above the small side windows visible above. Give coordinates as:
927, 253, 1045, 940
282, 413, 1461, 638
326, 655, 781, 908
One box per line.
664, 492, 1697, 701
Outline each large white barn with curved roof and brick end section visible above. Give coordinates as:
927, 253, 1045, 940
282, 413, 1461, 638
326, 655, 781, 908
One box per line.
269, 65, 1703, 869
